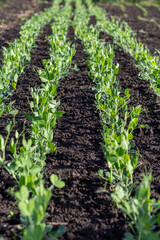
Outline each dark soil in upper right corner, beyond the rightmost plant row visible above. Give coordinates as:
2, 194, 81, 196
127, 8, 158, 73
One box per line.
99, 4, 160, 54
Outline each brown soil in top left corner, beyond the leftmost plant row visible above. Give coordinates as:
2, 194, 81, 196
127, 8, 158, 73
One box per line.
0, 0, 51, 66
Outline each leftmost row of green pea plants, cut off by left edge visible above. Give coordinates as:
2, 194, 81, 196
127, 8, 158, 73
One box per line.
0, 1, 60, 116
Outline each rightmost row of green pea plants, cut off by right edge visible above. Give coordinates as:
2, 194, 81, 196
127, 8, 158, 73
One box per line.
86, 0, 160, 97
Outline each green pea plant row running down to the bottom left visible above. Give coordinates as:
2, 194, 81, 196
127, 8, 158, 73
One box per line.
0, 1, 75, 240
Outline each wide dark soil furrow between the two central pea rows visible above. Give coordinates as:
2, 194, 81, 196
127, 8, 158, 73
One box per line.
45, 27, 126, 240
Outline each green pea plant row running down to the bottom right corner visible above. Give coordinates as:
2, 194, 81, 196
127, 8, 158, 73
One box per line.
73, 0, 160, 240
